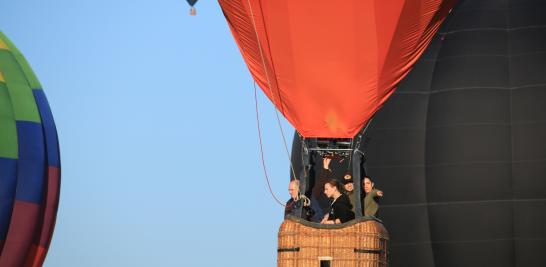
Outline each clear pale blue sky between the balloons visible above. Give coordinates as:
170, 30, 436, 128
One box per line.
0, 0, 293, 267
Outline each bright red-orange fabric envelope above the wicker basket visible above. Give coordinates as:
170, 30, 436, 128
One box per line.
219, 0, 455, 138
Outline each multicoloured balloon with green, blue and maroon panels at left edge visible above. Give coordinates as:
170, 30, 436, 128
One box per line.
0, 32, 61, 267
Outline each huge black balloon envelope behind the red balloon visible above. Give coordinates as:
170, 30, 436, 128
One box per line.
293, 0, 546, 267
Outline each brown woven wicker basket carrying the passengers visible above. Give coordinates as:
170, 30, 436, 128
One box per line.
277, 217, 389, 267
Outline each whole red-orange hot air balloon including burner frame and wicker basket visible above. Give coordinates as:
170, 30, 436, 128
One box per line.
218, 0, 455, 267
